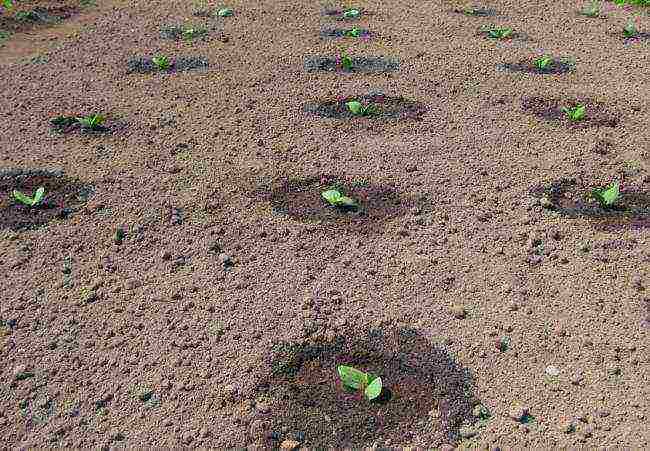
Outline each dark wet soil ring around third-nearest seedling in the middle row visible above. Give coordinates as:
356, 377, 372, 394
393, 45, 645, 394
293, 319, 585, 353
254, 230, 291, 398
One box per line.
305, 93, 427, 120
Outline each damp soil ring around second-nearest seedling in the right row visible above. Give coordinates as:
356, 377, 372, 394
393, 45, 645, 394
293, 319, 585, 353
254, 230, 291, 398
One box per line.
521, 97, 620, 128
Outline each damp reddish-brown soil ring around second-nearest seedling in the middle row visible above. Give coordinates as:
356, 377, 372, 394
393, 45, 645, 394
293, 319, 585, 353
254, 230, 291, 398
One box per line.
254, 174, 417, 233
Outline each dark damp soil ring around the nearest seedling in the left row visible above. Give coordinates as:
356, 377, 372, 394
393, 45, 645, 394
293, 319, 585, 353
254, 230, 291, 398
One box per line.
0, 169, 93, 230
